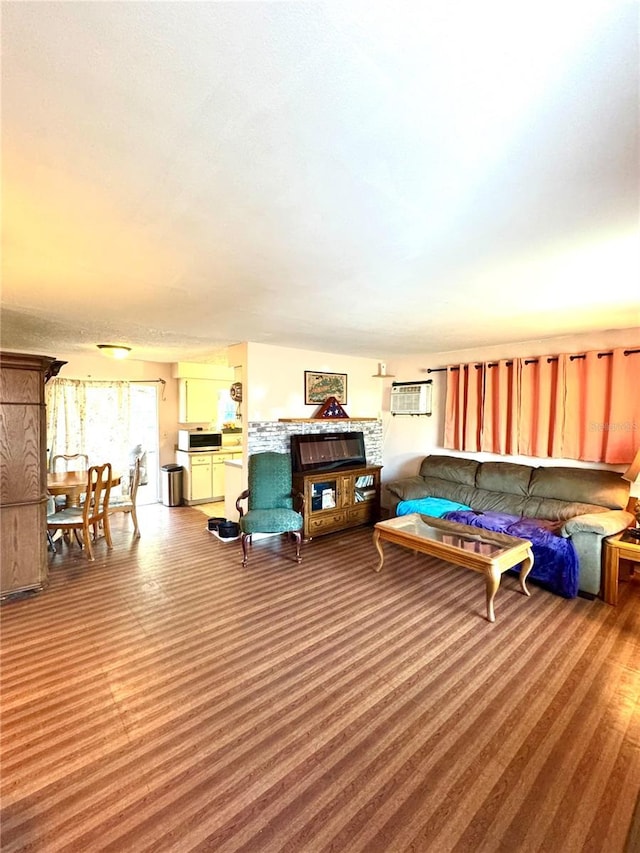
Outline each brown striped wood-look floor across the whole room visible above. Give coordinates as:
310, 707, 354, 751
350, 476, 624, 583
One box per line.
0, 505, 640, 853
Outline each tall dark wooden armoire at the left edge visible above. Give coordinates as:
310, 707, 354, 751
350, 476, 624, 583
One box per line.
0, 352, 55, 598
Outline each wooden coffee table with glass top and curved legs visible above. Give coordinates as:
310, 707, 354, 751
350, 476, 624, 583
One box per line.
373, 513, 533, 622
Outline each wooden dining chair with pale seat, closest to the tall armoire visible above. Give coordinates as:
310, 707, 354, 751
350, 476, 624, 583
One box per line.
47, 462, 113, 560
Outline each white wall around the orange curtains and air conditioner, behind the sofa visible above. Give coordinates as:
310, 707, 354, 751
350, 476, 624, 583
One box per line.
382, 328, 640, 482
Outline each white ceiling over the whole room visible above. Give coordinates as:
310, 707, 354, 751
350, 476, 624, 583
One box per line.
0, 0, 640, 361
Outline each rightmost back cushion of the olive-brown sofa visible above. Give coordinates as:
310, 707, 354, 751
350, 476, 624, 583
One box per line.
529, 466, 629, 509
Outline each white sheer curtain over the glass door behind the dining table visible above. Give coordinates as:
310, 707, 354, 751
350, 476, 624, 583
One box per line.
45, 377, 132, 493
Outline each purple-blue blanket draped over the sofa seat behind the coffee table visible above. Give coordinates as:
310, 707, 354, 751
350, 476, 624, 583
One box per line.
443, 510, 578, 598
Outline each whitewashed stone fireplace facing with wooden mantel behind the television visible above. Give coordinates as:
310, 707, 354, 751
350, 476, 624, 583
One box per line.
247, 418, 382, 465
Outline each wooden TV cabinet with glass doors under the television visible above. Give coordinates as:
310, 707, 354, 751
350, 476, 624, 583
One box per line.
293, 465, 382, 539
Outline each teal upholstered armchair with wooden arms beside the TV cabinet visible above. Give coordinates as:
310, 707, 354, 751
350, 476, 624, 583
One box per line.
236, 451, 304, 566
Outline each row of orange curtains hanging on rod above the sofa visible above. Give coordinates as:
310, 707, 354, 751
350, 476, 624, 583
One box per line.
444, 349, 640, 464
